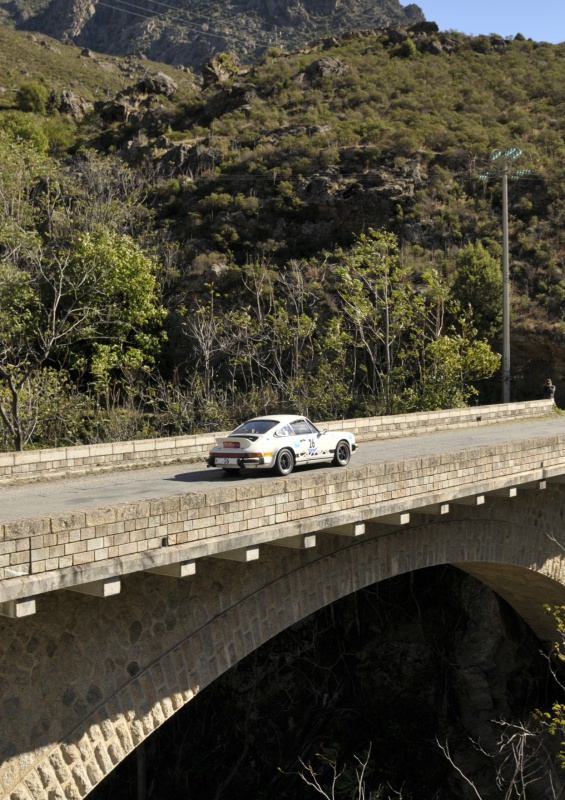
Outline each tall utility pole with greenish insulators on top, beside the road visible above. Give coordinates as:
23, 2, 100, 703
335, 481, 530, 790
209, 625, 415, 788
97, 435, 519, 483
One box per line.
479, 147, 529, 403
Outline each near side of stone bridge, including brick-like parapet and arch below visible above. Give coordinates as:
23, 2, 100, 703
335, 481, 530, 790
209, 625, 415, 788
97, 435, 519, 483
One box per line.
0, 404, 565, 800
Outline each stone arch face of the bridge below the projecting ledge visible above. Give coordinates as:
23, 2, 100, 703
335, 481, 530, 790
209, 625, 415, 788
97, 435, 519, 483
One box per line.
0, 492, 565, 800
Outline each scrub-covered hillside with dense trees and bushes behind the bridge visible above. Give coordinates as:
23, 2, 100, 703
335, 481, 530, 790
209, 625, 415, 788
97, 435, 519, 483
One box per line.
0, 24, 565, 449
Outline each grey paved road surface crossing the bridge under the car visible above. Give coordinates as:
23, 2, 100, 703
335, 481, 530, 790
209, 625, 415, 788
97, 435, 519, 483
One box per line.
0, 415, 565, 522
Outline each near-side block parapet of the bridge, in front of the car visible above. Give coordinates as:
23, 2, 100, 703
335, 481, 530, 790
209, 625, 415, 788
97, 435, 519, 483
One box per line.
0, 428, 565, 613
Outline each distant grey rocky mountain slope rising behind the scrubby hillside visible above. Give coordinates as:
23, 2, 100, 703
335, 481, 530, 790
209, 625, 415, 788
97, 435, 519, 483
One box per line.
8, 0, 425, 68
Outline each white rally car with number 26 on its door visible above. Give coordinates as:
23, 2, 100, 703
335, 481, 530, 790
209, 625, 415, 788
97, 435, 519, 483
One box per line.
207, 414, 357, 475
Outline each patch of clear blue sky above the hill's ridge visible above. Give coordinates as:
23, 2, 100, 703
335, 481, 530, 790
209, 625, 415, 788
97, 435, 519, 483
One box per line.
414, 0, 565, 44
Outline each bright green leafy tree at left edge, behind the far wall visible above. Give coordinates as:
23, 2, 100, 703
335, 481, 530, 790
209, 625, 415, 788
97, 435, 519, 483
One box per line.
0, 230, 164, 450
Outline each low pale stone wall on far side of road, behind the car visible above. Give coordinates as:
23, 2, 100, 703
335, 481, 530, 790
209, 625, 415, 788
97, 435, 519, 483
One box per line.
0, 400, 553, 485
